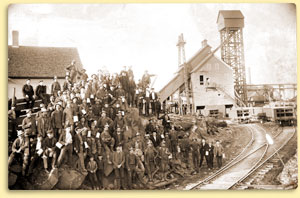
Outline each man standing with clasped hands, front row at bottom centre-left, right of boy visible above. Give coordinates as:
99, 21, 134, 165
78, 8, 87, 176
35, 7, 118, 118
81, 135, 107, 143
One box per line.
112, 146, 125, 190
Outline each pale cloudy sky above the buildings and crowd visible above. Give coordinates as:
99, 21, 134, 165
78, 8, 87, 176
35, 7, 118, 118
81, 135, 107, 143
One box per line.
8, 3, 297, 91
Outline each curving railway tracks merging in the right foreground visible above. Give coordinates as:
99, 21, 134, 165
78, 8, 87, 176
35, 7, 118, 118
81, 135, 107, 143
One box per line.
185, 125, 295, 190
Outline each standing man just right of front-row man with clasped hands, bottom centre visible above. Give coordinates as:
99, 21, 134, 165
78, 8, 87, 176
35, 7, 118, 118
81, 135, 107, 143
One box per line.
126, 147, 138, 190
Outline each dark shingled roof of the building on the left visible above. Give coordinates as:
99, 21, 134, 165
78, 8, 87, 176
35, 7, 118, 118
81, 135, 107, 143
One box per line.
8, 46, 82, 78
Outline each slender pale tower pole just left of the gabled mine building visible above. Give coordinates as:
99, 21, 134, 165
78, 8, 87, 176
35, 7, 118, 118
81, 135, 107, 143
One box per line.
176, 33, 190, 114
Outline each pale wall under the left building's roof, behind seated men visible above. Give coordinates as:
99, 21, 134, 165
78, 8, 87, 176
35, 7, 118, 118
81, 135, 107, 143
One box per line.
7, 79, 64, 98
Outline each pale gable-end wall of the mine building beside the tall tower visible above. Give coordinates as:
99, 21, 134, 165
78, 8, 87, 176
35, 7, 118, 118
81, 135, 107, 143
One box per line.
191, 56, 234, 115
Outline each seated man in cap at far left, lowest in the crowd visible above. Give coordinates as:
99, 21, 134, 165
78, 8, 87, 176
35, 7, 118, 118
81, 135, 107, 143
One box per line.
8, 131, 29, 176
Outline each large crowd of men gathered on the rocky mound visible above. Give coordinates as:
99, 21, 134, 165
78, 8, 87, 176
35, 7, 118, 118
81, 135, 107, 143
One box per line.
8, 62, 224, 189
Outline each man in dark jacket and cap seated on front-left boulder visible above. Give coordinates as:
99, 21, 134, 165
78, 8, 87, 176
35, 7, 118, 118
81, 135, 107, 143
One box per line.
42, 130, 57, 172
